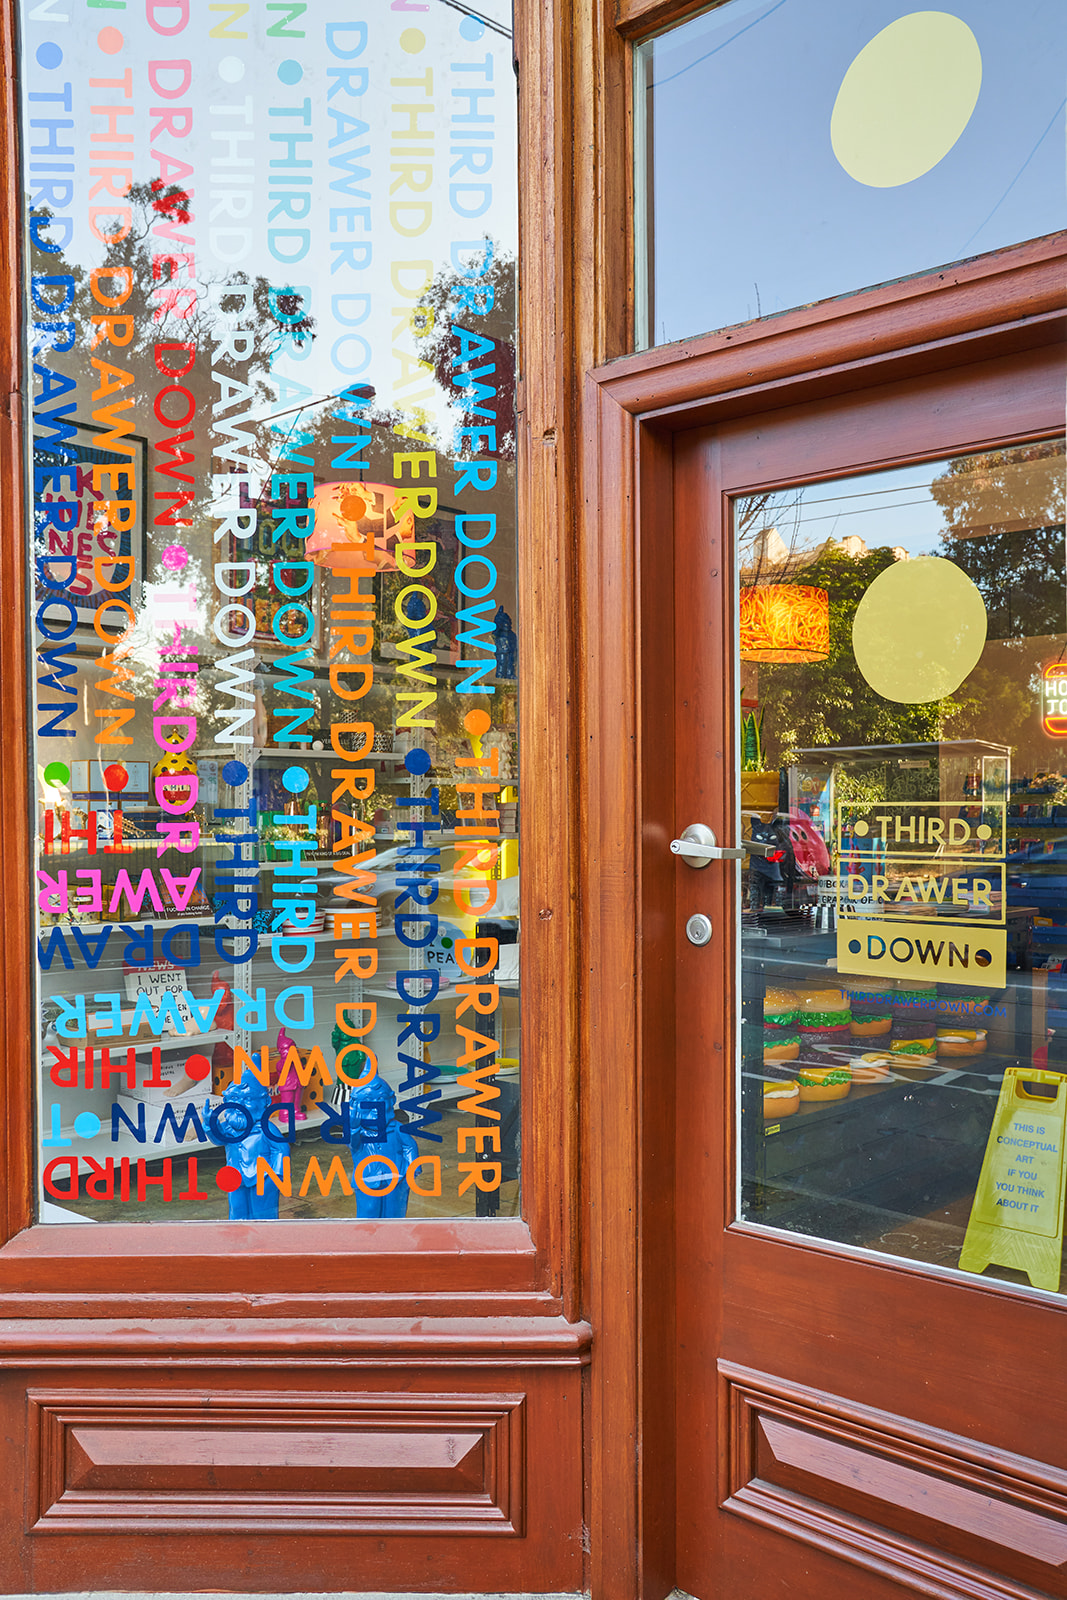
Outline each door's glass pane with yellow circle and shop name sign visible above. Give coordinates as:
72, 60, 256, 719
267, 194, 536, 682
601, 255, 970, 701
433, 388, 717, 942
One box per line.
734, 438, 1067, 1291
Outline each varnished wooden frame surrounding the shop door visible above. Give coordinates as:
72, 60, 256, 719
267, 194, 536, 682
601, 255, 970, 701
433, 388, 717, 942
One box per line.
579, 235, 1067, 1600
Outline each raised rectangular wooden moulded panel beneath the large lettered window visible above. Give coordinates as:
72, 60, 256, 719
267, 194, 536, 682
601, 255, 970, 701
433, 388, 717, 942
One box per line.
27, 1389, 526, 1538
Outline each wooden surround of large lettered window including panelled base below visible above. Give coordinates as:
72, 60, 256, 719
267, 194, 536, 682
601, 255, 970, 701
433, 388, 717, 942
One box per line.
0, 0, 591, 1594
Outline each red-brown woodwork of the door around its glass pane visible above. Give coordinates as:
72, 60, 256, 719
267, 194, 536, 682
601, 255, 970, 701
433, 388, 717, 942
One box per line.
673, 308, 1067, 1600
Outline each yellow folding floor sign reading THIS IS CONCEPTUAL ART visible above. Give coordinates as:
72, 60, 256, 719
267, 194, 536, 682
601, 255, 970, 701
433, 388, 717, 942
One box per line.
960, 1067, 1067, 1293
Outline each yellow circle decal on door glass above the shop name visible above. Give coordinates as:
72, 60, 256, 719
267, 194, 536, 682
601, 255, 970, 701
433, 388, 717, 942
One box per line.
853, 555, 987, 706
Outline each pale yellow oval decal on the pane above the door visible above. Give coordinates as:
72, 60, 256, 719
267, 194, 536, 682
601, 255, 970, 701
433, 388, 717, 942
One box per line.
830, 11, 982, 189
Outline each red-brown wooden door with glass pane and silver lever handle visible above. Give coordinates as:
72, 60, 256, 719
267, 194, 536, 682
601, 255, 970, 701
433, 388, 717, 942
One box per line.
675, 331, 1067, 1600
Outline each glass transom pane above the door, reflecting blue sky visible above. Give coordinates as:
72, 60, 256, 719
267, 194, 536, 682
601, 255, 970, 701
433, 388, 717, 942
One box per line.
637, 0, 1067, 349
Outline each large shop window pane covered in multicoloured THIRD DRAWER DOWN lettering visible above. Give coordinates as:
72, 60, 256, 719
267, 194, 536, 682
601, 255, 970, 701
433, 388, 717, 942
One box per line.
21, 0, 520, 1222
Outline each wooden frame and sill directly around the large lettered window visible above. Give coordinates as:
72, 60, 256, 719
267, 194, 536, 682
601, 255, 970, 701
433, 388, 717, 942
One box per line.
0, 0, 587, 1338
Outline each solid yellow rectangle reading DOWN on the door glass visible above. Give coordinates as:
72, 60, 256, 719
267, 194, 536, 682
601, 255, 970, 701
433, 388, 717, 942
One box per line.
837, 917, 1008, 989
